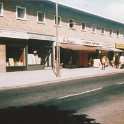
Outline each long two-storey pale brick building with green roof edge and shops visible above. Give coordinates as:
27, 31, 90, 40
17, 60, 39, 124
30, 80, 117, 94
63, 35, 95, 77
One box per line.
0, 0, 124, 72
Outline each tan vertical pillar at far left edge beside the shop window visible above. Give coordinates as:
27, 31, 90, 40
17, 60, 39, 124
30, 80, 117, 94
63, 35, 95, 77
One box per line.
0, 44, 6, 72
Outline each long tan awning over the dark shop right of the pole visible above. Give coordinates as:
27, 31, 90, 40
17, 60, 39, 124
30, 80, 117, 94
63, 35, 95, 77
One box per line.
60, 43, 96, 52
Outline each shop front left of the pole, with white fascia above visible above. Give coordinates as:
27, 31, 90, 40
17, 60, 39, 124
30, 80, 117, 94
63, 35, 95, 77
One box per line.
0, 30, 53, 72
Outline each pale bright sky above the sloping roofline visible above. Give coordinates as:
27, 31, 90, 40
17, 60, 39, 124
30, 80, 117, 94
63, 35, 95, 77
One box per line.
51, 0, 124, 24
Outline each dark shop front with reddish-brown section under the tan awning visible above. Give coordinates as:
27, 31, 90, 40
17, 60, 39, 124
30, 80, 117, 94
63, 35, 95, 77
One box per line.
60, 43, 97, 68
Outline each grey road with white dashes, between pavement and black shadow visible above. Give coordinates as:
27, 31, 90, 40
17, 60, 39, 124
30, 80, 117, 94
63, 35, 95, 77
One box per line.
0, 73, 124, 124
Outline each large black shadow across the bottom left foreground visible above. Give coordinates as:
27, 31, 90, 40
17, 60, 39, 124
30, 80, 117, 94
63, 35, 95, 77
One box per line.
0, 105, 100, 124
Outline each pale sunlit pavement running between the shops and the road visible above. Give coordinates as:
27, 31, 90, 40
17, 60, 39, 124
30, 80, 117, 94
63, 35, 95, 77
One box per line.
0, 67, 124, 90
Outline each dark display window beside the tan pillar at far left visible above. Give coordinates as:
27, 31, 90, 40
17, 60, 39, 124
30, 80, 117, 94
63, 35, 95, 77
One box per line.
6, 46, 25, 67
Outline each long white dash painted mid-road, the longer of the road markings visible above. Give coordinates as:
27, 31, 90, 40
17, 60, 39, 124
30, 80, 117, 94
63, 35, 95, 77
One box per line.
57, 87, 103, 99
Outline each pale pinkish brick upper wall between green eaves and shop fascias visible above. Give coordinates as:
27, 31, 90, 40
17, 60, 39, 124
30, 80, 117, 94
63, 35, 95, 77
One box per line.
0, 2, 123, 46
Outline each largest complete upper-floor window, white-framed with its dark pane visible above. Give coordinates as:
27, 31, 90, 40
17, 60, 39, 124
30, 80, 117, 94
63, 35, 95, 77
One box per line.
16, 6, 26, 19
